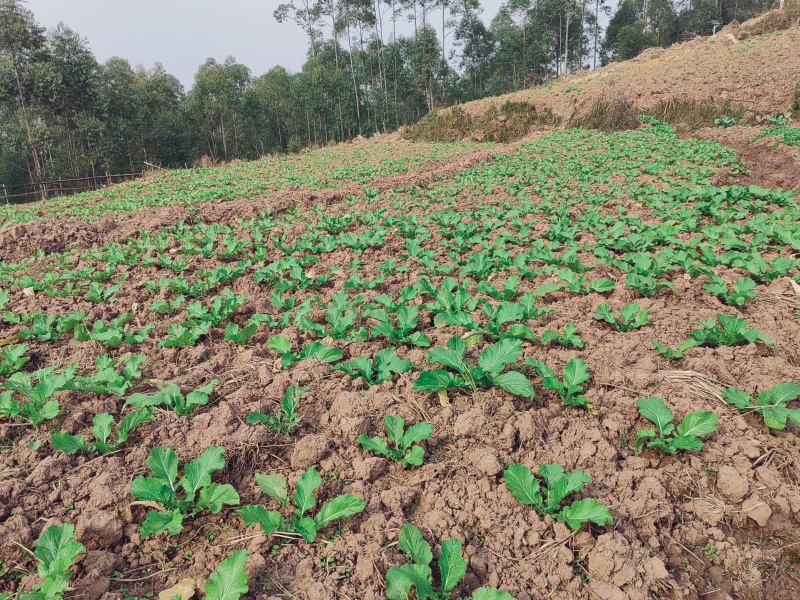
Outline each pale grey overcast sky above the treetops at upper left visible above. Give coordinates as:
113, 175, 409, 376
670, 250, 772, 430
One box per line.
27, 0, 503, 90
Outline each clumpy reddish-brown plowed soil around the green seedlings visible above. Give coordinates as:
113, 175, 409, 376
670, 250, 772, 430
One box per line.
0, 123, 800, 600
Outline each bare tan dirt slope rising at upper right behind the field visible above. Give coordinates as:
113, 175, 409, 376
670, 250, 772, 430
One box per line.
405, 11, 800, 142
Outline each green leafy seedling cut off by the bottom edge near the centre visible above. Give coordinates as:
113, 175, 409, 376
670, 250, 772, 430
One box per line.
386, 523, 514, 600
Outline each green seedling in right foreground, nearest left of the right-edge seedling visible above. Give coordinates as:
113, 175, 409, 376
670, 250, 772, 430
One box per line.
634, 396, 719, 456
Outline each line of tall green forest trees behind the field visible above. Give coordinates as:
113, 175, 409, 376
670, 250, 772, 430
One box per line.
0, 0, 772, 200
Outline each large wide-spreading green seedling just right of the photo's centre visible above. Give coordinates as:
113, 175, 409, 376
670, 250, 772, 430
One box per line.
414, 337, 534, 399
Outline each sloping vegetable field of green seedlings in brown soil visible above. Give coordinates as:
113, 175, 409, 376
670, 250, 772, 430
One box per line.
0, 117, 800, 600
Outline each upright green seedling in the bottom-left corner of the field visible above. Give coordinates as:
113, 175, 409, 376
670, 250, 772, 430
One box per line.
17, 523, 86, 600
